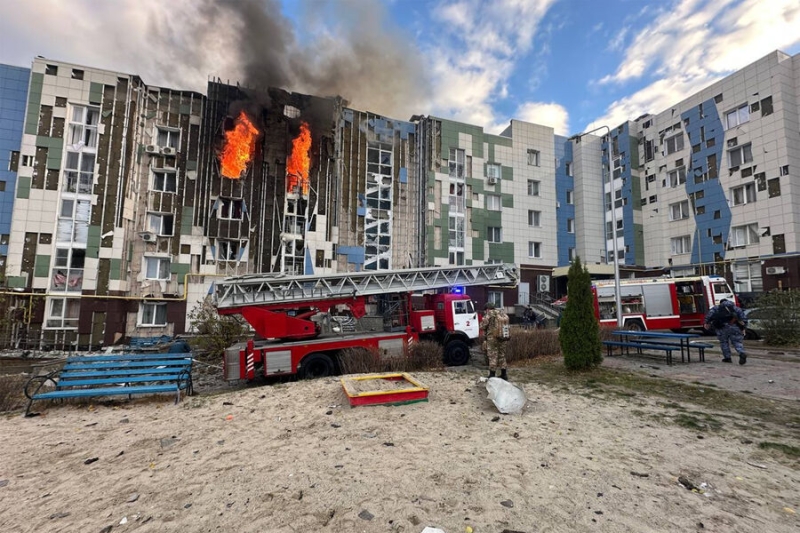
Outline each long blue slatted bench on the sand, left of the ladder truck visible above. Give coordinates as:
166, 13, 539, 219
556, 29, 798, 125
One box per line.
25, 353, 193, 416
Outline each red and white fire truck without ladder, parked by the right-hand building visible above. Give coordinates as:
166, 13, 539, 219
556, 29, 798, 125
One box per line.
592, 276, 738, 332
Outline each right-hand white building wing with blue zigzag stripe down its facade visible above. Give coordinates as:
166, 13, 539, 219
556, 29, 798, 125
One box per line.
632, 51, 800, 293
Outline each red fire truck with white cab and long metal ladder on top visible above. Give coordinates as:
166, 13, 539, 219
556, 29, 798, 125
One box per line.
214, 264, 519, 380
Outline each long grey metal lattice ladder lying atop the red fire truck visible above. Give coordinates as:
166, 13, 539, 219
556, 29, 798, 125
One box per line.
214, 264, 519, 309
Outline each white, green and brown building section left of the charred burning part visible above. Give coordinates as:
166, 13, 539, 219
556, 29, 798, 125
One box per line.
6, 58, 205, 347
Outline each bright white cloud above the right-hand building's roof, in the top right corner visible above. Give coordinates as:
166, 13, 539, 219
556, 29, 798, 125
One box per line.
592, 0, 800, 127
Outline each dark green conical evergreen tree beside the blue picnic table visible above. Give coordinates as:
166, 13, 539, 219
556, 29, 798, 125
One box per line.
558, 257, 603, 370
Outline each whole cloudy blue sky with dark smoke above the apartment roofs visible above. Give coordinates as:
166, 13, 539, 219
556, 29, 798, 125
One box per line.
0, 0, 800, 135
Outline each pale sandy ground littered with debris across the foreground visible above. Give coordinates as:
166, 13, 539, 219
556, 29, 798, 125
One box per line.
0, 356, 800, 533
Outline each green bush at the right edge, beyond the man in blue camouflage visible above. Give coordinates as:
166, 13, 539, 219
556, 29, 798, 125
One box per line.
752, 290, 800, 346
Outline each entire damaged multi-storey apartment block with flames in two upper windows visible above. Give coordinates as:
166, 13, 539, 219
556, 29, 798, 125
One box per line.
0, 52, 800, 347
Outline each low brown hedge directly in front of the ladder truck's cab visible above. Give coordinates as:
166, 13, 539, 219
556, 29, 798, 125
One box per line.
339, 341, 444, 374
